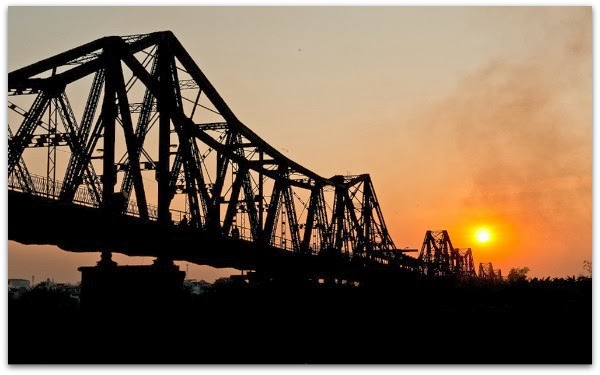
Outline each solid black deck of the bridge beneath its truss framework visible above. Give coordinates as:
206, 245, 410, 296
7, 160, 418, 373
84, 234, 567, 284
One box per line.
8, 190, 414, 279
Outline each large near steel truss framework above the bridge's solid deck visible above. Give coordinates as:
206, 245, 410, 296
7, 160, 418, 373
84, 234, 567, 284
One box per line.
8, 31, 408, 265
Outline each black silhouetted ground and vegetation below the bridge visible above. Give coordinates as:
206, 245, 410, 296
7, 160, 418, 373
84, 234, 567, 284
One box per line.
8, 279, 592, 364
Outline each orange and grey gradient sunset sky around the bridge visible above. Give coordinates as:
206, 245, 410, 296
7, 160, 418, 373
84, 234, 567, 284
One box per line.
7, 6, 592, 282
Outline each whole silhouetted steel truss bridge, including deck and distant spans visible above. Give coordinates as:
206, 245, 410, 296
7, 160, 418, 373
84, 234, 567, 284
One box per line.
8, 31, 500, 284
